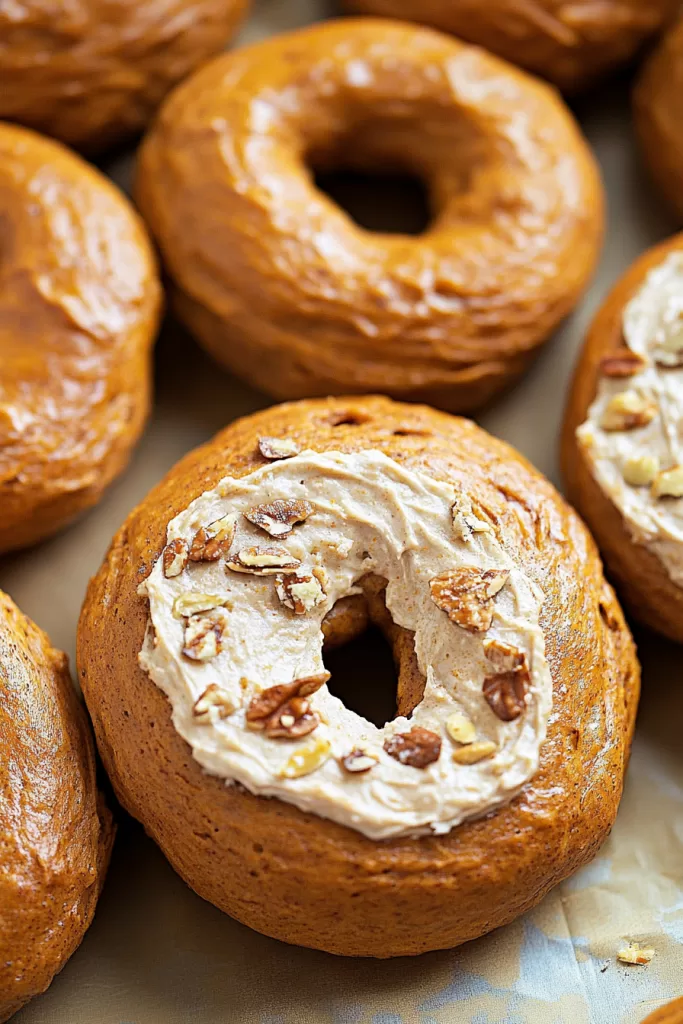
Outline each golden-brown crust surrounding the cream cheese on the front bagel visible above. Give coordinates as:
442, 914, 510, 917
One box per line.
78, 397, 639, 956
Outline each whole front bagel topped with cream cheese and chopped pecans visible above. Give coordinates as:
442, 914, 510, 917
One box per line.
78, 397, 639, 957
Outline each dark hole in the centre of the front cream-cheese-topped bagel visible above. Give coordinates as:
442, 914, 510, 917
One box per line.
325, 626, 398, 729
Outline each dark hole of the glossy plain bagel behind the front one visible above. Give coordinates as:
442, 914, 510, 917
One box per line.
310, 164, 432, 236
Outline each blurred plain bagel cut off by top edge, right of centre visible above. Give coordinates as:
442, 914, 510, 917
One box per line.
345, 0, 679, 92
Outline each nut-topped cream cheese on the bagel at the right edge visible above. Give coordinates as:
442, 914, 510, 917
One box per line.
577, 253, 683, 587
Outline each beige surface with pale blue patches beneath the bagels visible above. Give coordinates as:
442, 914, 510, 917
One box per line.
5, 0, 683, 1024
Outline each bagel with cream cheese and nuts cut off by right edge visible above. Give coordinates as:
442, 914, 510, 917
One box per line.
562, 234, 683, 642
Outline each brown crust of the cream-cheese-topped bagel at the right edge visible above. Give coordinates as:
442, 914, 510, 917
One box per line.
561, 234, 683, 641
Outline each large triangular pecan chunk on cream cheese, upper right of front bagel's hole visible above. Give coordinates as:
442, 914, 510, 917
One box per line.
429, 566, 510, 633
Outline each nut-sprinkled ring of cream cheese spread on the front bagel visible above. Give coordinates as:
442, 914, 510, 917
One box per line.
140, 451, 552, 839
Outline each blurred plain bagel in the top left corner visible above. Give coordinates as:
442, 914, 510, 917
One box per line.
0, 0, 247, 152
